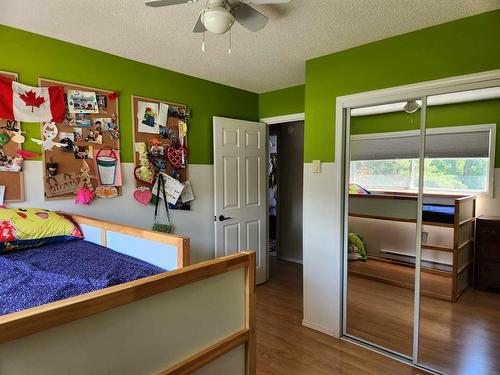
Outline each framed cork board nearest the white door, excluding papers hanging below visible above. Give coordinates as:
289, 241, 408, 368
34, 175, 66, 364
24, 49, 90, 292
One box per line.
131, 96, 190, 210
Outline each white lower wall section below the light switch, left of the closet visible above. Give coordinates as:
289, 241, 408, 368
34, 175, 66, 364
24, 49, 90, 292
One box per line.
303, 163, 341, 337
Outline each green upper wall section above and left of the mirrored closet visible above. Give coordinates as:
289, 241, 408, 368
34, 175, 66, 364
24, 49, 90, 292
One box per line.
304, 10, 500, 162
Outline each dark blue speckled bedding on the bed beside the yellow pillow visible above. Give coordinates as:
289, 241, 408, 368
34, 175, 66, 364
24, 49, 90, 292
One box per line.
0, 240, 165, 315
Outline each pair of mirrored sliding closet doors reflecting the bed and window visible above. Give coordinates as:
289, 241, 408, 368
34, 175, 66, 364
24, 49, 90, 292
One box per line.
343, 82, 500, 374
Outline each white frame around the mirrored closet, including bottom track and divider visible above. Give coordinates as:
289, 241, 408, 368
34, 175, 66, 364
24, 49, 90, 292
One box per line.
332, 69, 500, 372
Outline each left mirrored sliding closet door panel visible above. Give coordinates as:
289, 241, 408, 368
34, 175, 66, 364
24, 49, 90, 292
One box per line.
344, 100, 421, 359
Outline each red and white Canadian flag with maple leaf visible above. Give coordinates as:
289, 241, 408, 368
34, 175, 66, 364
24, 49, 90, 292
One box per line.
0, 77, 65, 122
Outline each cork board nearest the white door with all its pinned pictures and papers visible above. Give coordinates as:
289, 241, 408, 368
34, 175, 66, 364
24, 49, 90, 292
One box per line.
132, 96, 189, 210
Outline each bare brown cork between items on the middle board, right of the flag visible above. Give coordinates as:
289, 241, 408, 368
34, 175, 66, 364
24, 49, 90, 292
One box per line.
38, 78, 122, 200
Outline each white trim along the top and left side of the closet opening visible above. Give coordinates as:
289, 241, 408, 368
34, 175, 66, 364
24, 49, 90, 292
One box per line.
331, 69, 500, 368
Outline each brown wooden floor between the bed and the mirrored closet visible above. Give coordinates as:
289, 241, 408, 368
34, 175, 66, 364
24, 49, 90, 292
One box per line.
257, 257, 423, 375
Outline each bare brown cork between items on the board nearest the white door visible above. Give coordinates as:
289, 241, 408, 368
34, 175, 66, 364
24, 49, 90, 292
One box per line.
131, 96, 190, 210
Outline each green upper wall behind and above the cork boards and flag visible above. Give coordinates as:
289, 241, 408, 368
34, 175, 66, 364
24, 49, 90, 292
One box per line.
0, 25, 259, 164
